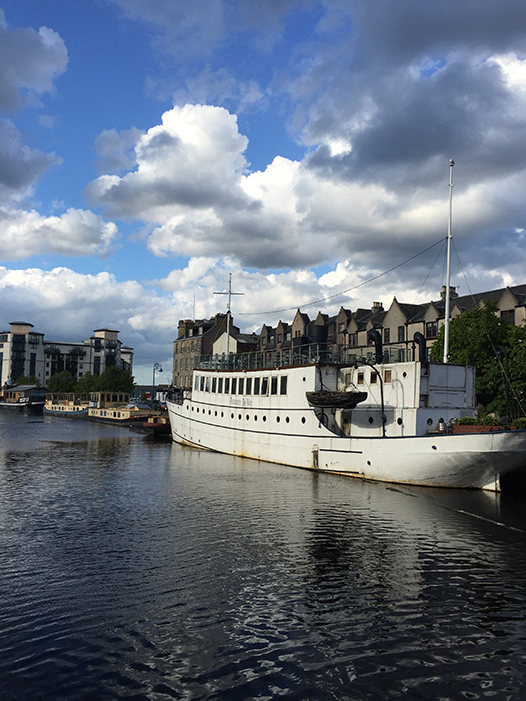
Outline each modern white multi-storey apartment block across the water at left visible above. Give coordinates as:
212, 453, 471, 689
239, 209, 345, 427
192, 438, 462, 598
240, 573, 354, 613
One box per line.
0, 321, 133, 387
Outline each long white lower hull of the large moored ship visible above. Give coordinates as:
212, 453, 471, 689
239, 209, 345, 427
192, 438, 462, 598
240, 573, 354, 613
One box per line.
168, 401, 526, 490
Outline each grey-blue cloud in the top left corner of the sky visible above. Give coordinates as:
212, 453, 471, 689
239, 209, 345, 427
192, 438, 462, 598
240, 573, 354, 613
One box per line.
0, 10, 68, 111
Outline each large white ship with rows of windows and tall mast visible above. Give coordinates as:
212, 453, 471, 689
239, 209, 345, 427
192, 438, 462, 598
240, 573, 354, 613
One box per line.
166, 160, 526, 491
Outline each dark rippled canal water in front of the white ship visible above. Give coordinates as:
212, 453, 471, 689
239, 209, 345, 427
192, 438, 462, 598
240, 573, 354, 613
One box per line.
0, 411, 526, 701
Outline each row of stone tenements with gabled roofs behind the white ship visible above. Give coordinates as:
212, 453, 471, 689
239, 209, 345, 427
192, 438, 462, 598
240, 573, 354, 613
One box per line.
174, 285, 526, 388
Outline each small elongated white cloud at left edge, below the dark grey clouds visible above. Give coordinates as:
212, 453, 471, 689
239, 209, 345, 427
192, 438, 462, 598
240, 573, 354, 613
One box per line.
0, 208, 118, 261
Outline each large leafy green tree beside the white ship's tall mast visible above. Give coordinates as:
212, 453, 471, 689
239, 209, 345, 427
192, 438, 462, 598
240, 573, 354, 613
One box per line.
431, 300, 526, 423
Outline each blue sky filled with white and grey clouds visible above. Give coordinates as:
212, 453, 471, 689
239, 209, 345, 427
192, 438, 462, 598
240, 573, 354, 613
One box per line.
0, 0, 526, 384
